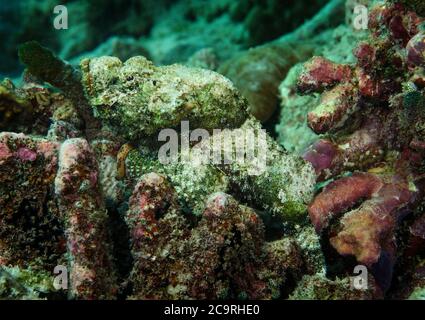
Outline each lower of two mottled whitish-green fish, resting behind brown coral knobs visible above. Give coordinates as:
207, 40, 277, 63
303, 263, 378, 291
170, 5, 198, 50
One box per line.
122, 119, 315, 224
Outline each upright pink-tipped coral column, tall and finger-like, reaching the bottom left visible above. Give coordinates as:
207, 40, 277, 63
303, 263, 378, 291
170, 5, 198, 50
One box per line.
55, 138, 117, 299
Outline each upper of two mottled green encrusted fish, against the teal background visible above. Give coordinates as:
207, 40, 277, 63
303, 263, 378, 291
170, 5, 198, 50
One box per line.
81, 56, 247, 141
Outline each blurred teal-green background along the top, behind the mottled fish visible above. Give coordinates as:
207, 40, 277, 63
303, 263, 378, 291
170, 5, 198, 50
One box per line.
0, 0, 326, 76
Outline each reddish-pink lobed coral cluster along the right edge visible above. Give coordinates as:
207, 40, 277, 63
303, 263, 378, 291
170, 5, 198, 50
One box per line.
297, 3, 425, 291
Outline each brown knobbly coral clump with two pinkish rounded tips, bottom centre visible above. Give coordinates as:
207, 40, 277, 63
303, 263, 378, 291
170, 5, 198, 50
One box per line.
126, 173, 303, 299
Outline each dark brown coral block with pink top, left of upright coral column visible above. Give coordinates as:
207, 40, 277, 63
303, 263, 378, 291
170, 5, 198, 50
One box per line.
0, 133, 63, 265
